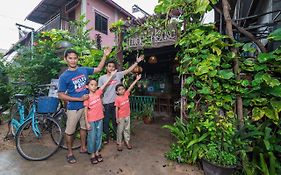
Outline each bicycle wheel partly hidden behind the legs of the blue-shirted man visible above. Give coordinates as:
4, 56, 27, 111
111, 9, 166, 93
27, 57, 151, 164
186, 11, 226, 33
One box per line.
54, 112, 81, 149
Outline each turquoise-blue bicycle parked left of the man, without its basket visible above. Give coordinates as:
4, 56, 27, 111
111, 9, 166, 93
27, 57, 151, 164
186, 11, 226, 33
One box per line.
10, 83, 63, 160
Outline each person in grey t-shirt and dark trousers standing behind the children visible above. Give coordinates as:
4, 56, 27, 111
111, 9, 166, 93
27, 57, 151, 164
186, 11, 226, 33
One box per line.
98, 55, 144, 144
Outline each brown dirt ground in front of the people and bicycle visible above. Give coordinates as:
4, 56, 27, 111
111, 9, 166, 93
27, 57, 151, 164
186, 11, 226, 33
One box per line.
0, 117, 203, 175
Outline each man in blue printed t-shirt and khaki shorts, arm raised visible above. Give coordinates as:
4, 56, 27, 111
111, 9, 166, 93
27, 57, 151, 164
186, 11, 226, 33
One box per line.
58, 49, 111, 164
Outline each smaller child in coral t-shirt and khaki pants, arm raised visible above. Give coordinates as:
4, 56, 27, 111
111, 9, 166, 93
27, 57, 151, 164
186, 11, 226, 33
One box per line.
114, 75, 141, 151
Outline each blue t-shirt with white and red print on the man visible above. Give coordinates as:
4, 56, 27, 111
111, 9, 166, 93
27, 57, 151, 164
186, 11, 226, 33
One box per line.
58, 67, 94, 110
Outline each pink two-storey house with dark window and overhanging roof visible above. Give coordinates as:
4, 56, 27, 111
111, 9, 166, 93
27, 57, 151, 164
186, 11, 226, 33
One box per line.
5, 0, 135, 55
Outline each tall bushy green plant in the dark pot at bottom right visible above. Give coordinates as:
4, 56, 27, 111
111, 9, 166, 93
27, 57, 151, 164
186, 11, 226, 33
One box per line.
199, 108, 239, 175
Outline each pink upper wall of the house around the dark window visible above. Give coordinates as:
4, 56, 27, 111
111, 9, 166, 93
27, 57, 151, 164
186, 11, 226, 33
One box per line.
86, 0, 127, 47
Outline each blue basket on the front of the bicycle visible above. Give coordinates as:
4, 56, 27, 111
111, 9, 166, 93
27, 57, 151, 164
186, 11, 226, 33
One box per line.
37, 96, 59, 113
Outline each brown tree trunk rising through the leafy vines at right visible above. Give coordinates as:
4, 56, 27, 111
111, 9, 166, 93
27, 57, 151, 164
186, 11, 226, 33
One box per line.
222, 0, 244, 128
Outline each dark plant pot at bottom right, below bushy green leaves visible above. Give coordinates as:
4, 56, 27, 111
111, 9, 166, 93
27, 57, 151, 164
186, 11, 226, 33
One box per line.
202, 159, 236, 175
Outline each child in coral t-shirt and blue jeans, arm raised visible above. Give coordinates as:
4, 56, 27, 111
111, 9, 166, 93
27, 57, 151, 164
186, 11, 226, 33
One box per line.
84, 71, 117, 164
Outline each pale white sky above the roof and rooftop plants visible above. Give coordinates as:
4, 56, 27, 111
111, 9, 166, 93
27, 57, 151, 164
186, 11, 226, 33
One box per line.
0, 0, 158, 50
